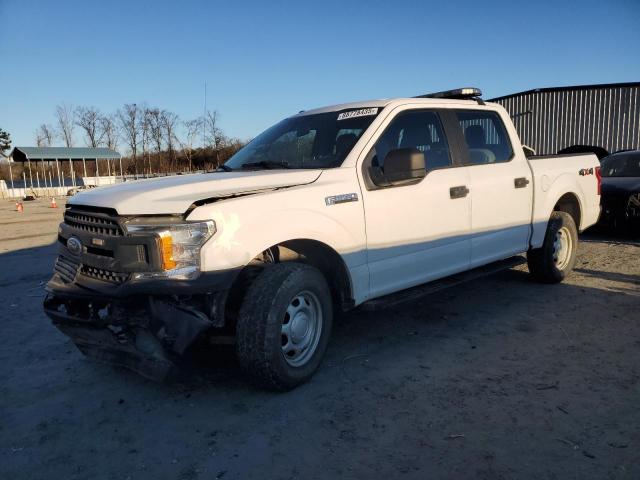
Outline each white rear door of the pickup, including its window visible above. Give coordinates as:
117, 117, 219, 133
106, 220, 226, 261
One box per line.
455, 109, 533, 267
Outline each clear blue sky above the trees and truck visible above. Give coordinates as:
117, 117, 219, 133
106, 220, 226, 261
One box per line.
0, 0, 640, 150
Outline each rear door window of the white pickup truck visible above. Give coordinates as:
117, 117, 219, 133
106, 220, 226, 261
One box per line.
455, 110, 513, 165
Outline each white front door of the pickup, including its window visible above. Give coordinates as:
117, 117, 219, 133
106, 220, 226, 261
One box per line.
360, 110, 471, 298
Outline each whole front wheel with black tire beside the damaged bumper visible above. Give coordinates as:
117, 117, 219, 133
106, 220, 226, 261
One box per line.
236, 263, 333, 391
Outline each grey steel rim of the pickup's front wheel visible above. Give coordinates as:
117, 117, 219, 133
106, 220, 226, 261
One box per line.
281, 290, 323, 367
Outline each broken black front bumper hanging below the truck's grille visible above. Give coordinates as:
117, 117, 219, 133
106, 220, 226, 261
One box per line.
44, 293, 225, 381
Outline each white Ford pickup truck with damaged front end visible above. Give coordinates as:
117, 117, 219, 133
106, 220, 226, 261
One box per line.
44, 89, 600, 390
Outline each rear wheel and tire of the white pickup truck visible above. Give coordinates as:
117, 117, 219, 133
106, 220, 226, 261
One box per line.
527, 212, 578, 283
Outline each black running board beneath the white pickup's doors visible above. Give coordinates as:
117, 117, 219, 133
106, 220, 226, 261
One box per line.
360, 255, 527, 311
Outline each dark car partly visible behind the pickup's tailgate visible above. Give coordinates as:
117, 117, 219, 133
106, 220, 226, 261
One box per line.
600, 150, 640, 231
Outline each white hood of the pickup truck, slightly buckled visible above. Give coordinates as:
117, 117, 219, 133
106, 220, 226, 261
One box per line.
68, 170, 322, 215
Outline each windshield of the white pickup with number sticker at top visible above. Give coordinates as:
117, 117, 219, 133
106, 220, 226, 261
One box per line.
223, 108, 381, 170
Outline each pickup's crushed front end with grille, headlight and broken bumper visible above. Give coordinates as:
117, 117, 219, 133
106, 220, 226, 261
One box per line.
44, 205, 235, 381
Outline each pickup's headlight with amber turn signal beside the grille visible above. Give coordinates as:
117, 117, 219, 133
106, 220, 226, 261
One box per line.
126, 221, 216, 280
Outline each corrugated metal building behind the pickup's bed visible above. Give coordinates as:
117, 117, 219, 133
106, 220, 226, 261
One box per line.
490, 82, 640, 155
